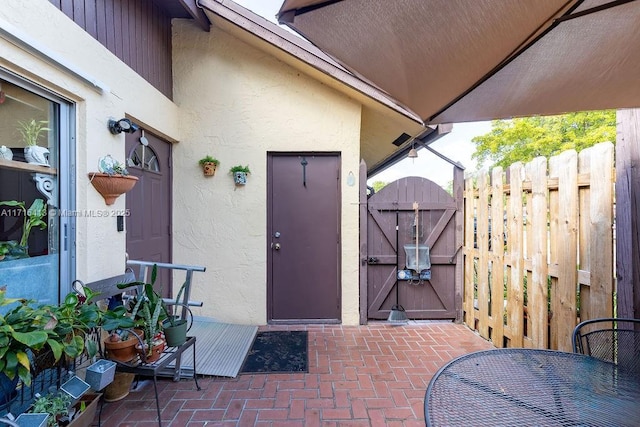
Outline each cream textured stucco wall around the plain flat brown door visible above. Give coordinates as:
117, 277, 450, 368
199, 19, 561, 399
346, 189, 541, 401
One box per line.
173, 21, 361, 324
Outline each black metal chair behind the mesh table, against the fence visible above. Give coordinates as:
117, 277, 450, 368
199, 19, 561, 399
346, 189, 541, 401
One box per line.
573, 317, 640, 374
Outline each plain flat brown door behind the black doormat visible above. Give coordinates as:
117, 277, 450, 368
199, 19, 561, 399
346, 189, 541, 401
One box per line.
267, 153, 341, 323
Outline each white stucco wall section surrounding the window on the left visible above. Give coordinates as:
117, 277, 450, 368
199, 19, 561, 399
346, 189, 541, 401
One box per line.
0, 0, 180, 285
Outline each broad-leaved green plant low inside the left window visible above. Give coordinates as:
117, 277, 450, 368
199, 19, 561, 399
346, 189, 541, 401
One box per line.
0, 199, 47, 261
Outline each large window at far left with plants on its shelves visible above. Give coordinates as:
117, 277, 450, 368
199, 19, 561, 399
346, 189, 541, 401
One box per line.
0, 75, 74, 303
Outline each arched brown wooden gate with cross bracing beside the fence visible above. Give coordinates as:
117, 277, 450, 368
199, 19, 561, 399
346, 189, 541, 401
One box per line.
361, 170, 462, 322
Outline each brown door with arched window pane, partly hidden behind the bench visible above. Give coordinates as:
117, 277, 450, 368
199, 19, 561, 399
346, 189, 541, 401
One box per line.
126, 131, 171, 296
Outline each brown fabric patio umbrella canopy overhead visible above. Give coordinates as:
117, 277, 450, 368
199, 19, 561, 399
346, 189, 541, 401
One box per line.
278, 0, 640, 124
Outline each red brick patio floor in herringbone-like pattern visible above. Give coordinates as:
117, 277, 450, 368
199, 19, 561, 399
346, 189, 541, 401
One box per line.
97, 322, 492, 427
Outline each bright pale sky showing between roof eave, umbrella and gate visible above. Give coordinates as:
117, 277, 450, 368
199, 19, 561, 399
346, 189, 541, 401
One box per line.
234, 0, 491, 187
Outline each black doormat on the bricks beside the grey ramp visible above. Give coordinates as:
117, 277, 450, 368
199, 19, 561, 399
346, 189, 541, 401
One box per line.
240, 331, 309, 374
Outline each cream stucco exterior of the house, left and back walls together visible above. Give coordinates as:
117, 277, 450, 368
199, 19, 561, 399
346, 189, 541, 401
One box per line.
0, 0, 417, 325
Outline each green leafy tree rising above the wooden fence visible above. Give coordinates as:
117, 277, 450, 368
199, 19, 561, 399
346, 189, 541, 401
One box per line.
471, 110, 616, 168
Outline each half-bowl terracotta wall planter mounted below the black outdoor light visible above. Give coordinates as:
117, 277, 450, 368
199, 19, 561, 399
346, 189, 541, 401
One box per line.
89, 155, 138, 205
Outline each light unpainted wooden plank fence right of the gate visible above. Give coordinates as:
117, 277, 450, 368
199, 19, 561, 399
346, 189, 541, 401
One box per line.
463, 143, 615, 351
